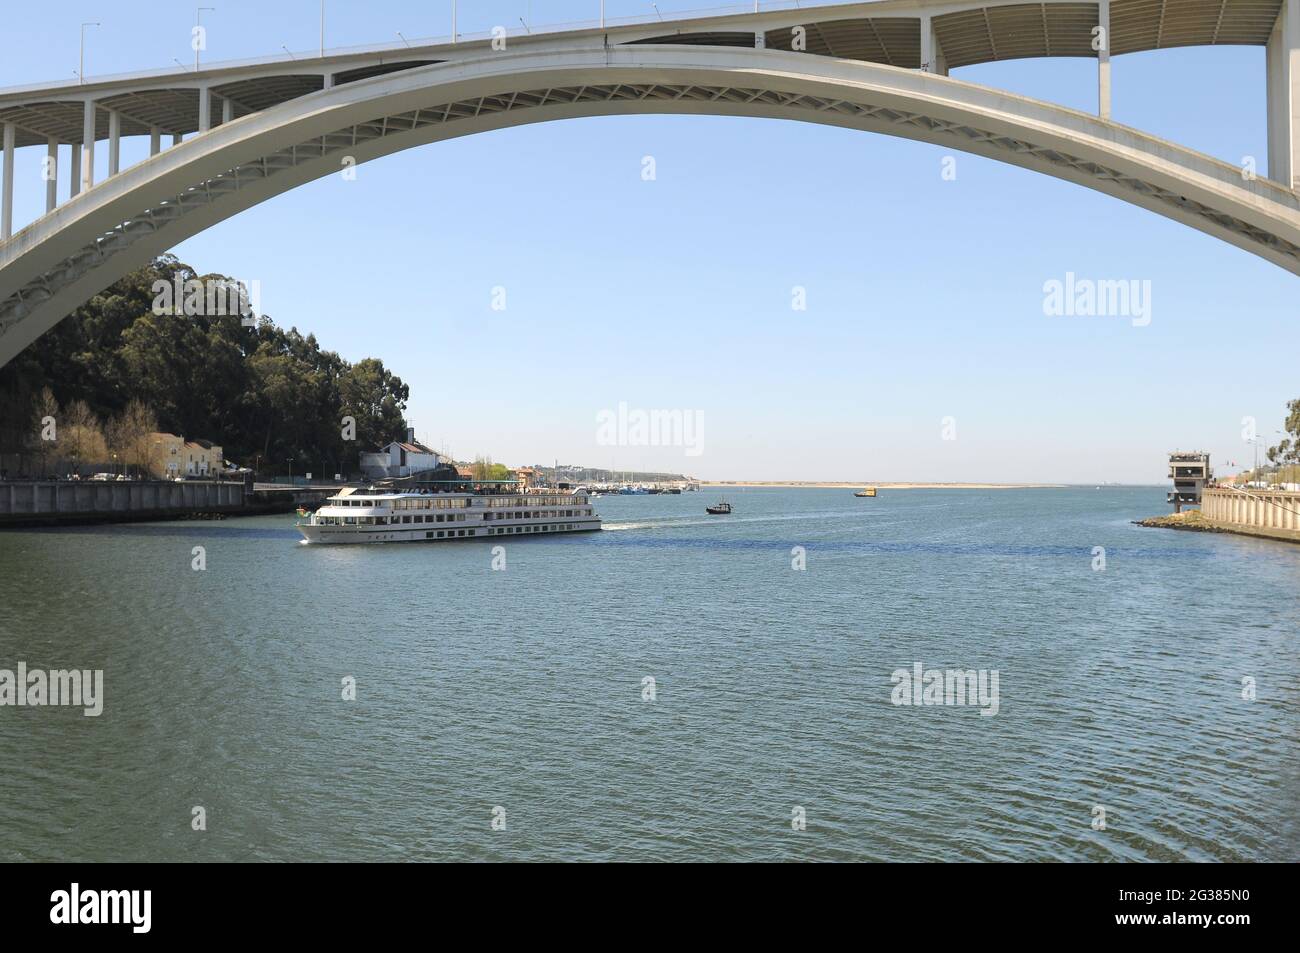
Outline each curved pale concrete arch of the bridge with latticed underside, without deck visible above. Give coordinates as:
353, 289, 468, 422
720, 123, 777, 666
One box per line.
0, 44, 1300, 365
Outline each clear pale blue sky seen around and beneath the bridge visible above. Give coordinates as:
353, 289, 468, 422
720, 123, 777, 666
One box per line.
0, 0, 1300, 482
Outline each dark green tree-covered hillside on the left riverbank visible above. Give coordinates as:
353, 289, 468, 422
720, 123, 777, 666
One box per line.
0, 255, 410, 476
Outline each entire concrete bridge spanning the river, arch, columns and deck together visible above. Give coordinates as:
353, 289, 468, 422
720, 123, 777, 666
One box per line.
0, 0, 1300, 364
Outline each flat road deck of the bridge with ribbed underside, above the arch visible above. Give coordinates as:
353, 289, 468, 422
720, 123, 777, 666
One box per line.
0, 0, 1283, 147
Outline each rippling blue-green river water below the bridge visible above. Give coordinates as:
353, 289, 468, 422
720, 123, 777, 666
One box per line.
0, 488, 1300, 861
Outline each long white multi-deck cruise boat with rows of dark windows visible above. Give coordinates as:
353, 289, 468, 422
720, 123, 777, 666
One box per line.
298, 488, 601, 543
